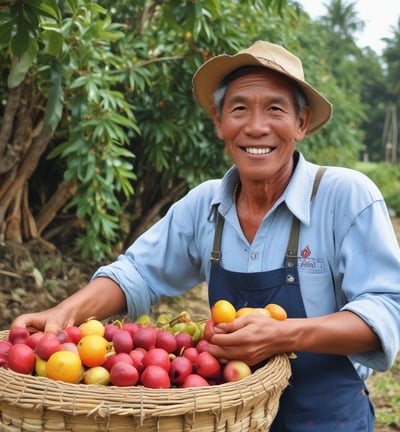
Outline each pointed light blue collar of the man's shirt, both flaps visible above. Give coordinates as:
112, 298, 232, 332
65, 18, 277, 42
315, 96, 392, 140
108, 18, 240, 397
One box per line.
211, 151, 318, 225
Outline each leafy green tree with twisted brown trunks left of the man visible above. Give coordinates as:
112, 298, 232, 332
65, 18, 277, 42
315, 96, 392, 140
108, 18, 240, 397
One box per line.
0, 0, 285, 258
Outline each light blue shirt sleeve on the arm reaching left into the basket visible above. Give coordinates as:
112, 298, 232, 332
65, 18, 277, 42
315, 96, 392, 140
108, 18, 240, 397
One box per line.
93, 183, 214, 319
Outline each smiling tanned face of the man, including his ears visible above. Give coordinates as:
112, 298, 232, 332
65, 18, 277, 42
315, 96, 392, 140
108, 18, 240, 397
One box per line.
214, 69, 309, 183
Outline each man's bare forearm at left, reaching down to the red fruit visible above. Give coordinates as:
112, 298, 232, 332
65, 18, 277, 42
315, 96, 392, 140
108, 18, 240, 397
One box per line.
55, 277, 126, 324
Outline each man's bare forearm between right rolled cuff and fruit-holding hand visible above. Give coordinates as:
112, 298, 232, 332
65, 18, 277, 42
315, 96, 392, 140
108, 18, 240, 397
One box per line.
283, 311, 382, 355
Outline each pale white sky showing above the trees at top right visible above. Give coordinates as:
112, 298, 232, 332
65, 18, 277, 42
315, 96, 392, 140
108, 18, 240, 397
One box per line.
297, 0, 400, 54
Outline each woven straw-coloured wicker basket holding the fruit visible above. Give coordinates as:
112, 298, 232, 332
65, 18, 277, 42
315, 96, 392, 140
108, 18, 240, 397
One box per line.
0, 331, 290, 432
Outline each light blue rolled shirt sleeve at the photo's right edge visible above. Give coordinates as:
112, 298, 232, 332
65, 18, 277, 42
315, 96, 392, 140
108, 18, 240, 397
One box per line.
339, 200, 400, 371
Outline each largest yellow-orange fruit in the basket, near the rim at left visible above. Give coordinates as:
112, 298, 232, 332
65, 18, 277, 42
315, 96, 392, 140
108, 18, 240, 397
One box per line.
46, 351, 82, 383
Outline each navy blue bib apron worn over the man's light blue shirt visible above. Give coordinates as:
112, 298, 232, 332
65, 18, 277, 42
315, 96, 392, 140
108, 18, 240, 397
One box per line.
208, 169, 374, 432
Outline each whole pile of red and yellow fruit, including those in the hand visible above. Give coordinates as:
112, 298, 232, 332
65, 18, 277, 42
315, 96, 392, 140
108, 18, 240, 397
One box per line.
0, 300, 286, 389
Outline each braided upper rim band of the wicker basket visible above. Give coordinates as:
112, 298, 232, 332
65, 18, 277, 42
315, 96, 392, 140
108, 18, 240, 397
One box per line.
0, 330, 291, 415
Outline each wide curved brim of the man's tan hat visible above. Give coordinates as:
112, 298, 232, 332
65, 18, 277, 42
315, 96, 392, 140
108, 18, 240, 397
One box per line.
193, 53, 332, 135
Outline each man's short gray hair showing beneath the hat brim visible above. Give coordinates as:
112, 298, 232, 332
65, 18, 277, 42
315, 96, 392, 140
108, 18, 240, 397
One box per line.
213, 66, 308, 116
